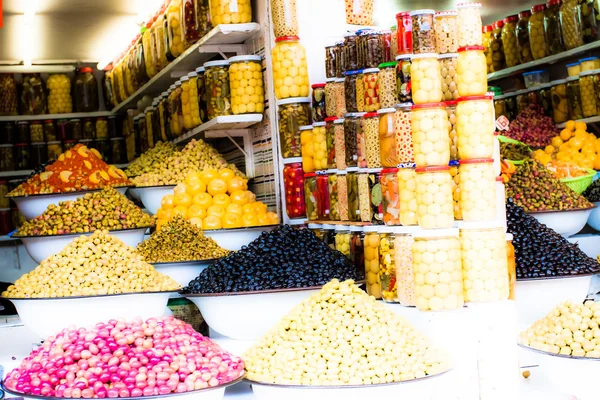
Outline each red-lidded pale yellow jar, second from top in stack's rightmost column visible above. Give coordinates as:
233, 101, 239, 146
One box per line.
457, 46, 487, 96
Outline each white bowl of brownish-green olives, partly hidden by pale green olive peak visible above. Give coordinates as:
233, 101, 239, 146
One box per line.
12, 227, 148, 264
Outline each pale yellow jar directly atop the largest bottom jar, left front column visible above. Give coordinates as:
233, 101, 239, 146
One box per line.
415, 164, 454, 229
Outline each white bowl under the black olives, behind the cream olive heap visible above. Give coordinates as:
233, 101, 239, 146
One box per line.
184, 288, 320, 340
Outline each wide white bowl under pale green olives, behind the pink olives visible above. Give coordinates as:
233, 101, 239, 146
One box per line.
8, 292, 173, 339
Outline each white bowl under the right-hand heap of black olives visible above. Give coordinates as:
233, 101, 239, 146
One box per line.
515, 275, 593, 331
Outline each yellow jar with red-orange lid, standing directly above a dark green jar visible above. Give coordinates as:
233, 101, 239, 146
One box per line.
274, 36, 310, 100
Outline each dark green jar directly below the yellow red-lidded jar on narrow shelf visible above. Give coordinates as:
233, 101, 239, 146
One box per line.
277, 97, 312, 158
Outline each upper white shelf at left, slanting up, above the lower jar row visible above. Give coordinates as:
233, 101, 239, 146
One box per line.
112, 22, 260, 113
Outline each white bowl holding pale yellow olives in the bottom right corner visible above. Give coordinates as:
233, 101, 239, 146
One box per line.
520, 345, 600, 400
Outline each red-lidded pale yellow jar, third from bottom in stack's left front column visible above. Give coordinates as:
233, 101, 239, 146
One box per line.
412, 103, 450, 167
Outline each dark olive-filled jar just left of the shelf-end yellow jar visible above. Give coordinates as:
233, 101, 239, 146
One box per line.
204, 60, 232, 120
